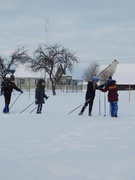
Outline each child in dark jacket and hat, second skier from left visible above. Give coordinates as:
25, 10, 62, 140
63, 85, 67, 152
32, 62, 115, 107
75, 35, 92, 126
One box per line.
35, 79, 48, 114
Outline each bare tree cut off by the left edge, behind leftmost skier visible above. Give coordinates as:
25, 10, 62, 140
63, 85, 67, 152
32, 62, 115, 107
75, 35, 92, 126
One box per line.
0, 46, 31, 78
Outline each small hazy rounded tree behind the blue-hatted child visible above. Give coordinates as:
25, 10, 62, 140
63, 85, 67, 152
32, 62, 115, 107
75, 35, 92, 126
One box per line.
82, 62, 99, 81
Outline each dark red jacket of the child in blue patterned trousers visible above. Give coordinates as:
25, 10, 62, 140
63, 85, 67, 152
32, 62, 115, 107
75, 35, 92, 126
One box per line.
100, 83, 118, 102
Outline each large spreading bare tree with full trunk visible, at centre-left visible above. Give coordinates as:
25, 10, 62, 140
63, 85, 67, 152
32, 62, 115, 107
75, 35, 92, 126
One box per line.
31, 44, 78, 95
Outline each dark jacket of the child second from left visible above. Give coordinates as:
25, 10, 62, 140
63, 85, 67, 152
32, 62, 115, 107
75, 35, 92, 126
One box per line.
35, 84, 48, 104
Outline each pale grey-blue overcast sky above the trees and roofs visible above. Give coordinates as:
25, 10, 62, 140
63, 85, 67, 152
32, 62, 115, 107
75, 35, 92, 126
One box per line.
0, 0, 135, 76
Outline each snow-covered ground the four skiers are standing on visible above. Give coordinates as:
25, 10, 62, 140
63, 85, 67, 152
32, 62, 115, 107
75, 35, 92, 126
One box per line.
0, 91, 135, 180
